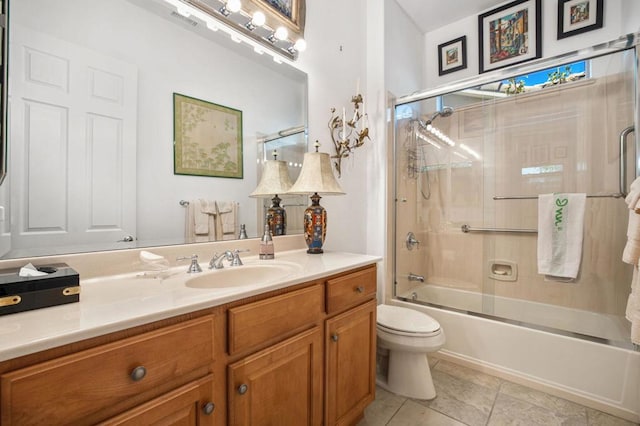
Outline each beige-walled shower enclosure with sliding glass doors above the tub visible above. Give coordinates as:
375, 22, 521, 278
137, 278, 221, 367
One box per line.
393, 36, 638, 349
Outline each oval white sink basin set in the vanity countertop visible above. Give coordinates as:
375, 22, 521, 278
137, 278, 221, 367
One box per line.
185, 262, 302, 288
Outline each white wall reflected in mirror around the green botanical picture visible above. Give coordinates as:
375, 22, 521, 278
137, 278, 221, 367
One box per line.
12, 0, 308, 242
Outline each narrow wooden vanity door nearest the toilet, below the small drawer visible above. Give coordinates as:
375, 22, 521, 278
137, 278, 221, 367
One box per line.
325, 299, 376, 425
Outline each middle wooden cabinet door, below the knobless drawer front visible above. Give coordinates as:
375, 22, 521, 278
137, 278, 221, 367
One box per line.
228, 326, 323, 426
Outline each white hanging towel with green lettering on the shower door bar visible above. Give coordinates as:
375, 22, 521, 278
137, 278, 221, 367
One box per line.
538, 194, 586, 279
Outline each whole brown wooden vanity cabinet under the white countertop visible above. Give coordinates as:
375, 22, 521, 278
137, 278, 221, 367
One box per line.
0, 264, 376, 426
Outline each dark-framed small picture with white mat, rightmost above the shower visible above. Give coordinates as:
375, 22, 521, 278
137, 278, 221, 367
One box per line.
558, 0, 604, 40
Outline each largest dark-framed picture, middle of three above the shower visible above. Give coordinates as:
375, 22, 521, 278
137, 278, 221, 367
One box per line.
478, 0, 542, 73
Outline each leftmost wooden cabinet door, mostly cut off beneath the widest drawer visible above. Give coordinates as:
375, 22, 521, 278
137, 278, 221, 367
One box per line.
100, 375, 215, 426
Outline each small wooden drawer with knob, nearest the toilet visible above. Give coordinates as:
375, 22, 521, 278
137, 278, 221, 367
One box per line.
327, 265, 377, 314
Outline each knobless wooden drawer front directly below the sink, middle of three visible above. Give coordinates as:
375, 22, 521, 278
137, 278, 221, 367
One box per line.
228, 285, 324, 355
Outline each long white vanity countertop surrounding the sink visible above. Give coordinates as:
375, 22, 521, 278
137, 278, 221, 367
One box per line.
0, 250, 381, 361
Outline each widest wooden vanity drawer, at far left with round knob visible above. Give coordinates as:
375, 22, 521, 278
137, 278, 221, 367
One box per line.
0, 316, 213, 425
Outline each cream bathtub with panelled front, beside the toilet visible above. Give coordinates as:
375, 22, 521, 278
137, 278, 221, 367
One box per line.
388, 285, 640, 423
